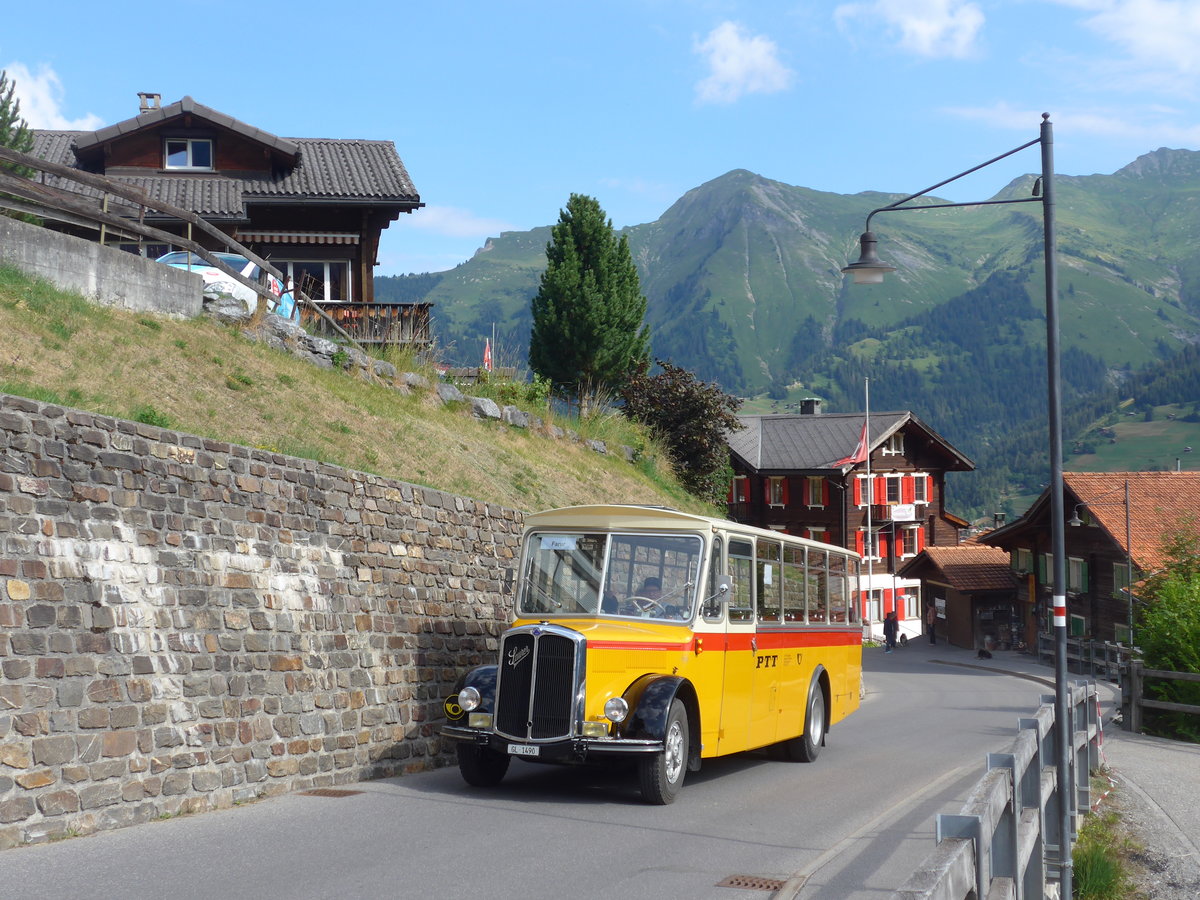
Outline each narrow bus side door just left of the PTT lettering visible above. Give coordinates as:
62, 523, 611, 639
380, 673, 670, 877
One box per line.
718, 538, 756, 755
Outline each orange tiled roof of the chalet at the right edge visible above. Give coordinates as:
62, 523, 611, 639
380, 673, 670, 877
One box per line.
1063, 472, 1200, 571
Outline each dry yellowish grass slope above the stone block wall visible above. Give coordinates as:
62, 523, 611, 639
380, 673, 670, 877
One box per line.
0, 268, 710, 512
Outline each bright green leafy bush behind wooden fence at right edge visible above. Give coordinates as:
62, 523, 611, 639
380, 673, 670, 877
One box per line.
1138, 522, 1200, 743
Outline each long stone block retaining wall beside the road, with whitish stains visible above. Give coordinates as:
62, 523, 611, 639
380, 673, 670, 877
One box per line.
0, 395, 522, 847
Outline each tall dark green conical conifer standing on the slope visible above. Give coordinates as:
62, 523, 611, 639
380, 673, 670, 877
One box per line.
529, 193, 649, 412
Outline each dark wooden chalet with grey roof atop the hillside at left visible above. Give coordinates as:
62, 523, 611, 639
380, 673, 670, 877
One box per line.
34, 94, 430, 343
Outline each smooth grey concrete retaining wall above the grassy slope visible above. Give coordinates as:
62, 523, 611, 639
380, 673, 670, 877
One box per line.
0, 216, 204, 318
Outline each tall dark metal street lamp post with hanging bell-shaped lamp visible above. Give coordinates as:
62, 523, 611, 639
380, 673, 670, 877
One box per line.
842, 113, 1074, 898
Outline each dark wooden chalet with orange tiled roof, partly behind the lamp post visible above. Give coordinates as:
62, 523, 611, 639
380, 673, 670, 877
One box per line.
979, 472, 1200, 643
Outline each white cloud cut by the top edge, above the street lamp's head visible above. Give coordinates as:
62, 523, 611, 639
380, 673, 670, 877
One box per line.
834, 0, 984, 59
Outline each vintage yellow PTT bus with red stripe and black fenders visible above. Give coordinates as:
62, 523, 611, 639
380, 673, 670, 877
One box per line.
443, 505, 863, 804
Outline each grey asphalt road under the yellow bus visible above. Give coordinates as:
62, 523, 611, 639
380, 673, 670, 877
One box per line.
0, 642, 1048, 900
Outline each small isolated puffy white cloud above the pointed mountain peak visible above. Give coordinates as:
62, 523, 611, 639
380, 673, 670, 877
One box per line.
692, 22, 793, 103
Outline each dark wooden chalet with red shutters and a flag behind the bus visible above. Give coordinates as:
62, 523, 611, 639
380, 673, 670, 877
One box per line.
727, 400, 974, 637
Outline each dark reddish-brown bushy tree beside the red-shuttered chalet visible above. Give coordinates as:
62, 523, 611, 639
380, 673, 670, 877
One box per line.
622, 360, 743, 504
